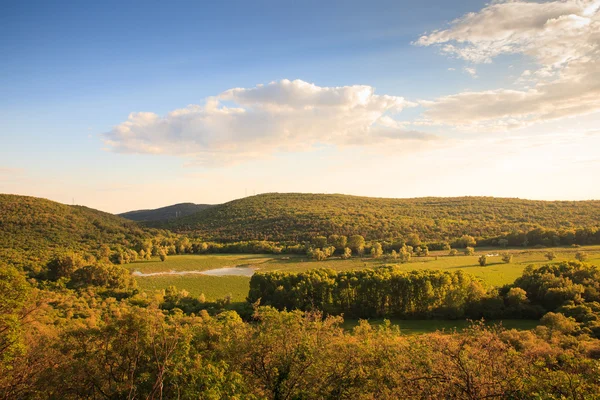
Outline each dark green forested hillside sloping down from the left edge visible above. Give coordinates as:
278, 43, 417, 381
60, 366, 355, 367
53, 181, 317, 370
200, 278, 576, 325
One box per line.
0, 194, 159, 263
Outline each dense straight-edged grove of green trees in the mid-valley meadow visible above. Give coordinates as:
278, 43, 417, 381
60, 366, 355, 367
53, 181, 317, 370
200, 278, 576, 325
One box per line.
248, 267, 485, 318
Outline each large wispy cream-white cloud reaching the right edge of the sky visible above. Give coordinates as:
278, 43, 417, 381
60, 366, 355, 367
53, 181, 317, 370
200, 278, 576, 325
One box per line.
416, 0, 600, 130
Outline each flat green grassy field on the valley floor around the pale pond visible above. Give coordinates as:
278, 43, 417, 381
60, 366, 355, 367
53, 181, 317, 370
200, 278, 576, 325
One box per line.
128, 246, 600, 301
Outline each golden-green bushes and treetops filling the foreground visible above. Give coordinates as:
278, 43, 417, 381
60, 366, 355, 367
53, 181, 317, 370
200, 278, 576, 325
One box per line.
0, 267, 600, 399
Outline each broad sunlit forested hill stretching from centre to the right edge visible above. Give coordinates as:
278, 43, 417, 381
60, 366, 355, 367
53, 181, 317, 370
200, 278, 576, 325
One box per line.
153, 193, 600, 241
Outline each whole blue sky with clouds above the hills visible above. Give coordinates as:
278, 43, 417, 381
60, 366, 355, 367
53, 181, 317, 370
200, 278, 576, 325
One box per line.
0, 0, 600, 213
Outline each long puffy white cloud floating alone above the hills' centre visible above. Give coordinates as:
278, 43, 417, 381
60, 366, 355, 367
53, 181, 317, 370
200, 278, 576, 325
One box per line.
103, 80, 432, 164
